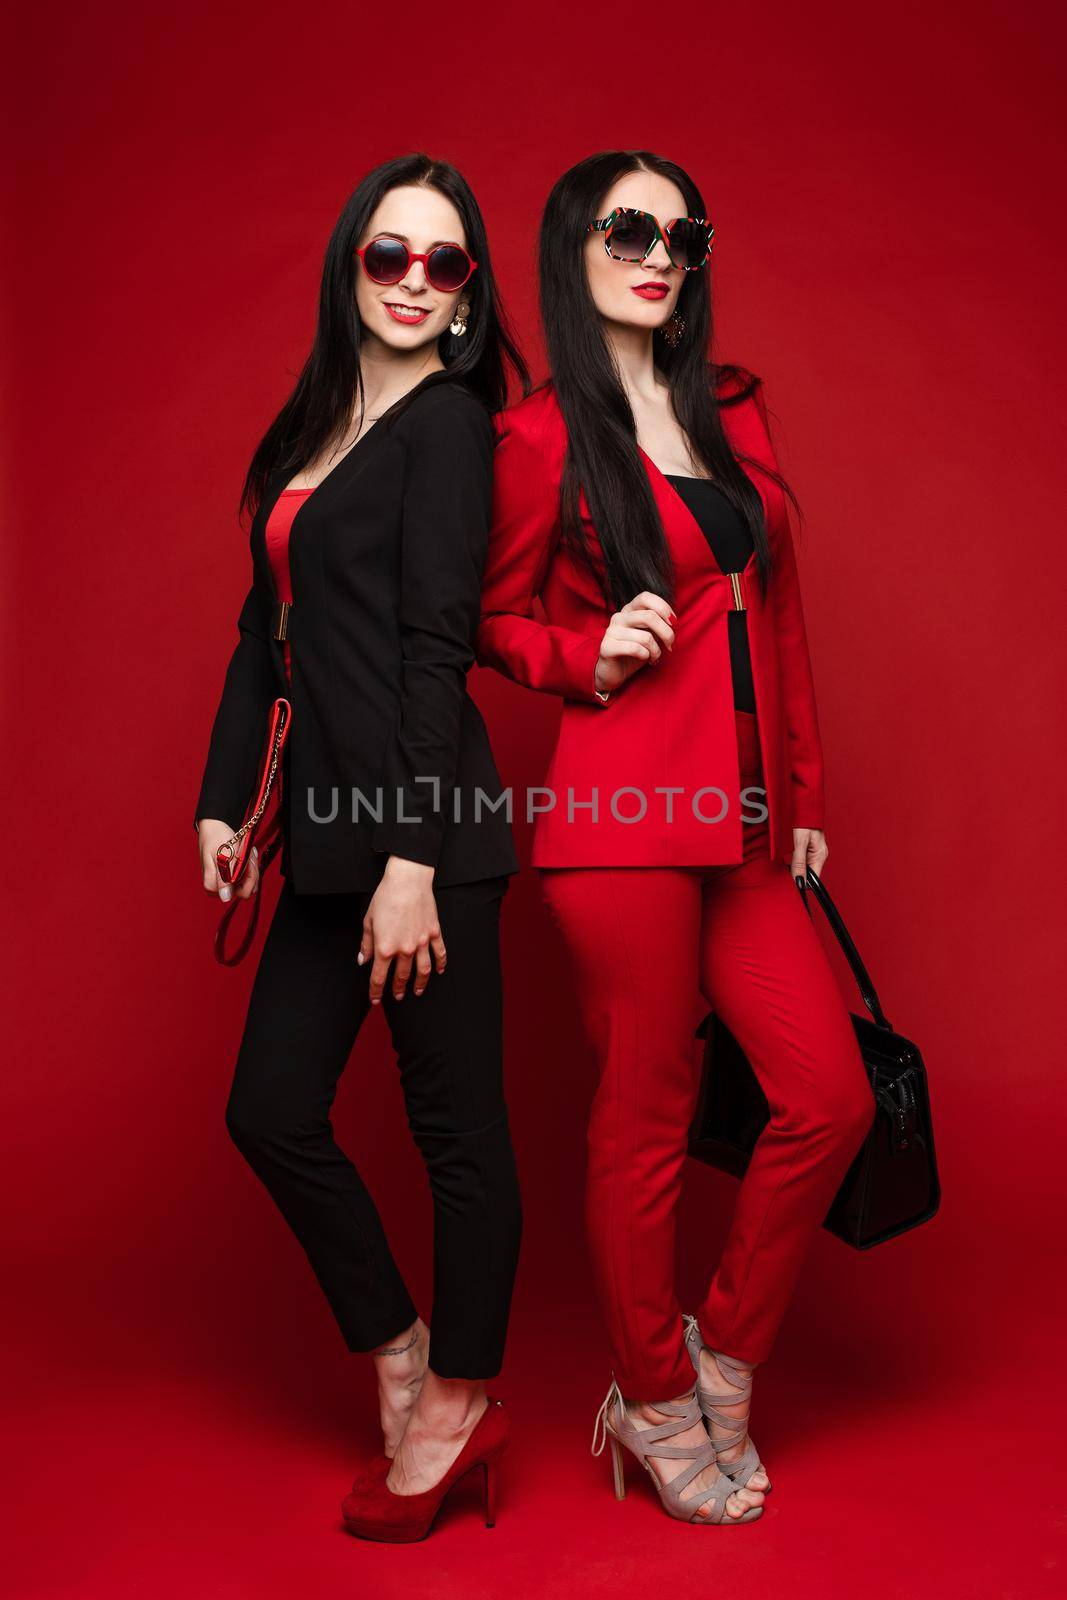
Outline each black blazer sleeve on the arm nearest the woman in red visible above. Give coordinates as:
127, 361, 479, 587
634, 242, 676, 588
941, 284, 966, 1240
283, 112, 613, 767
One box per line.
371, 389, 493, 866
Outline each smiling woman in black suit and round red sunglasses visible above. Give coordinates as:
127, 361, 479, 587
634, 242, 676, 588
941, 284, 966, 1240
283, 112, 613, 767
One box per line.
195, 155, 528, 1536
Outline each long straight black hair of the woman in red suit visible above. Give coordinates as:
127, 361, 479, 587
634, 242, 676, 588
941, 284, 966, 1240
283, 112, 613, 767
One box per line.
539, 150, 797, 608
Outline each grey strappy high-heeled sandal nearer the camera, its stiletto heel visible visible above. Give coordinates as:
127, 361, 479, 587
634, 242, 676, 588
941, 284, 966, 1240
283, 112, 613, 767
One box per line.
592, 1382, 763, 1526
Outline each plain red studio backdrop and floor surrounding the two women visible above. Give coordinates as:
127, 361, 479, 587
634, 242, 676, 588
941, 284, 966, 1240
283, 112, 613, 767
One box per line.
2, 0, 1065, 1600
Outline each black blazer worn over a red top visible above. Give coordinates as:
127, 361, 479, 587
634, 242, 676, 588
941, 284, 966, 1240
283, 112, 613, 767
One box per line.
195, 379, 518, 894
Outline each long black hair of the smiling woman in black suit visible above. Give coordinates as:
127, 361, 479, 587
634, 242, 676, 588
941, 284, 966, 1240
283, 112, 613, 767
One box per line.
240, 152, 530, 515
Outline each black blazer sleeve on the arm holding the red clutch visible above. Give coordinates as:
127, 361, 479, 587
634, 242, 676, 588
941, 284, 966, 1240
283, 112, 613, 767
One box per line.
195, 584, 277, 830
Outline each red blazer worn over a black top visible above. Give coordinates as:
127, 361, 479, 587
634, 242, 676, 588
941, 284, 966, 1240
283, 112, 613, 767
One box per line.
475, 372, 824, 867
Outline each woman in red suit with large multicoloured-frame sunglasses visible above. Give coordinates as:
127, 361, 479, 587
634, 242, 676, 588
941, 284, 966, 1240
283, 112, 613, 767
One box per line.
477, 150, 873, 1526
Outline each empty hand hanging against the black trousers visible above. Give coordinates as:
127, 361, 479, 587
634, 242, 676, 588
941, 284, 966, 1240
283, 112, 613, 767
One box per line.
357, 856, 446, 1005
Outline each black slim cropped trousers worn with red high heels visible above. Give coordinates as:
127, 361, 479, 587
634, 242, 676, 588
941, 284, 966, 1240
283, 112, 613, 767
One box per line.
226, 877, 522, 1379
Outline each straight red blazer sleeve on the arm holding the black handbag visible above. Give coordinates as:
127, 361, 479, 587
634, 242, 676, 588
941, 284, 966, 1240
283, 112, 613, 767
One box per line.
753, 384, 825, 829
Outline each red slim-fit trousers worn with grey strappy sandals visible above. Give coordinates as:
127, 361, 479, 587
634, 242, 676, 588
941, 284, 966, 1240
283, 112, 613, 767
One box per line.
541, 712, 873, 1400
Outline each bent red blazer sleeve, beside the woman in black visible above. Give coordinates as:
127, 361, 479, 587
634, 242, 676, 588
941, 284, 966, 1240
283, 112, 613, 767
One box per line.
477, 419, 605, 706
